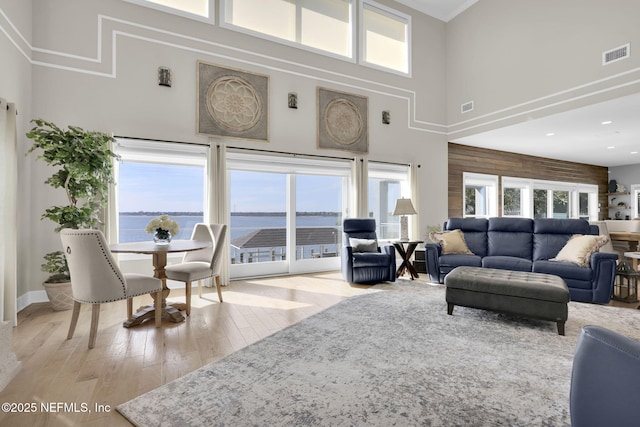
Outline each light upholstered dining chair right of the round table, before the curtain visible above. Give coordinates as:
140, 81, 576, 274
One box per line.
165, 223, 227, 316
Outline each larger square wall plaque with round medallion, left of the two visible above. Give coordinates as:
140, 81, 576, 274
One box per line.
197, 61, 269, 141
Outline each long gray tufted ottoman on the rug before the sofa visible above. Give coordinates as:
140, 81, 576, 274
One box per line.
444, 267, 570, 335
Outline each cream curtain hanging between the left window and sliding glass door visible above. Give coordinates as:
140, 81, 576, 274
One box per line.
207, 141, 231, 286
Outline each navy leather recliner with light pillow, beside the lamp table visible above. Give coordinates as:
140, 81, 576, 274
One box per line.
342, 218, 396, 283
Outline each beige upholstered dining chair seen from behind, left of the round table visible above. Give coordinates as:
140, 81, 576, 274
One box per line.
60, 228, 162, 348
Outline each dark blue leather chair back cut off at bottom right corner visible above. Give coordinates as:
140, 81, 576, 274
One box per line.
570, 326, 640, 427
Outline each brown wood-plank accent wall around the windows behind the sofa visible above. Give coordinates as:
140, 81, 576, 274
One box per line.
448, 142, 609, 219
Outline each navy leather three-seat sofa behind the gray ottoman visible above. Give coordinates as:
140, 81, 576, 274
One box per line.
425, 218, 618, 304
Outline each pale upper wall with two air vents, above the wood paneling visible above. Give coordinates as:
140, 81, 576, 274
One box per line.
446, 0, 640, 139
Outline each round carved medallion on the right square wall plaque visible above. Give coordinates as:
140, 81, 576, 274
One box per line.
324, 98, 364, 145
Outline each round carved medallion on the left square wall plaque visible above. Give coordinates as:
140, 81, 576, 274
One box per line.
207, 76, 262, 132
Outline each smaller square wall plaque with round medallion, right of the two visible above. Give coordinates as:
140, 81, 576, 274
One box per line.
318, 87, 369, 153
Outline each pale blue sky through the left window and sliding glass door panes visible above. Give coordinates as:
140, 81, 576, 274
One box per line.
118, 162, 342, 212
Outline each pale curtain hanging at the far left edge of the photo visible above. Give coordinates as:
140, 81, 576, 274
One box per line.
0, 98, 18, 326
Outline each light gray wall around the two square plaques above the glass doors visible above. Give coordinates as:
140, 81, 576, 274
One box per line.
0, 0, 447, 302
